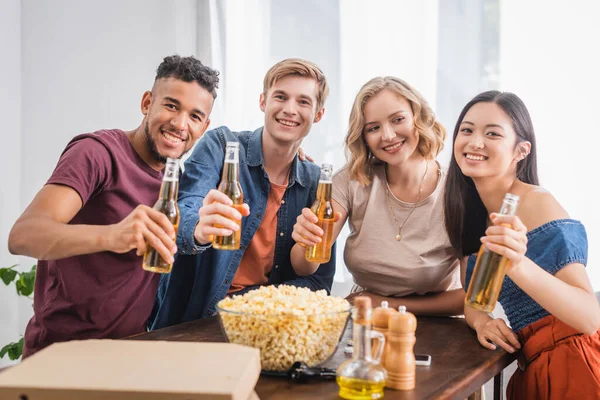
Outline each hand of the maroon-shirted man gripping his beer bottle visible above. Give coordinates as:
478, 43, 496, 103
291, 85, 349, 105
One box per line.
106, 205, 177, 263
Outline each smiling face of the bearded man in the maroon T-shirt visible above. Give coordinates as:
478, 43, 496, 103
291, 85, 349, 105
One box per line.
142, 78, 214, 164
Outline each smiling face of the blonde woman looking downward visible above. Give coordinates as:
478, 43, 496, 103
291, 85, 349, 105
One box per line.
363, 89, 419, 165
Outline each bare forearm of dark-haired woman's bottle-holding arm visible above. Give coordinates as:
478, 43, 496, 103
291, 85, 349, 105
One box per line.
508, 258, 600, 334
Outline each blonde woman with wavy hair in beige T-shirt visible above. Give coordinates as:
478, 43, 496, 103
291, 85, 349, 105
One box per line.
292, 77, 464, 315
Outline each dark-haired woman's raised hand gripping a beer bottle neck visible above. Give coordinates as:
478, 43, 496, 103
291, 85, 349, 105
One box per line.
481, 213, 527, 267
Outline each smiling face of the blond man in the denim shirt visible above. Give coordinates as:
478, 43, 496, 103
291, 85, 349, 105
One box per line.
260, 75, 325, 145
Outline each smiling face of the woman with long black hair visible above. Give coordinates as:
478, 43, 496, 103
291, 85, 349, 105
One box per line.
454, 102, 529, 178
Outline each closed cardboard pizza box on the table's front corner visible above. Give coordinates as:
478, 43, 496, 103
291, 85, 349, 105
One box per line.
0, 340, 260, 400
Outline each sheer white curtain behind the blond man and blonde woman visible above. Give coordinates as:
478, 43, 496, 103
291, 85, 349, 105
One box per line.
200, 0, 438, 294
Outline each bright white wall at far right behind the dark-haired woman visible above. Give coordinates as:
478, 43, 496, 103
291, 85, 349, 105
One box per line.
500, 0, 600, 291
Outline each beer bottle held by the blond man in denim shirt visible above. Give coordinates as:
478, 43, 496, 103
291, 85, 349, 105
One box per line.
212, 142, 244, 250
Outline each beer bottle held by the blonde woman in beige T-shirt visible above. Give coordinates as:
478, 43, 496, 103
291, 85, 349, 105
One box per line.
305, 164, 335, 264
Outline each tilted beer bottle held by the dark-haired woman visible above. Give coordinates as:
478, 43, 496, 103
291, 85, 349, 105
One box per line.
465, 193, 519, 312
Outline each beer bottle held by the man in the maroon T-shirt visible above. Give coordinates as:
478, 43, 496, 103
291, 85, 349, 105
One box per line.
142, 158, 179, 274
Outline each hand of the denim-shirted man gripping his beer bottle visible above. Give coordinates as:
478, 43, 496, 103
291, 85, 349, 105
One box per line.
194, 189, 250, 245
